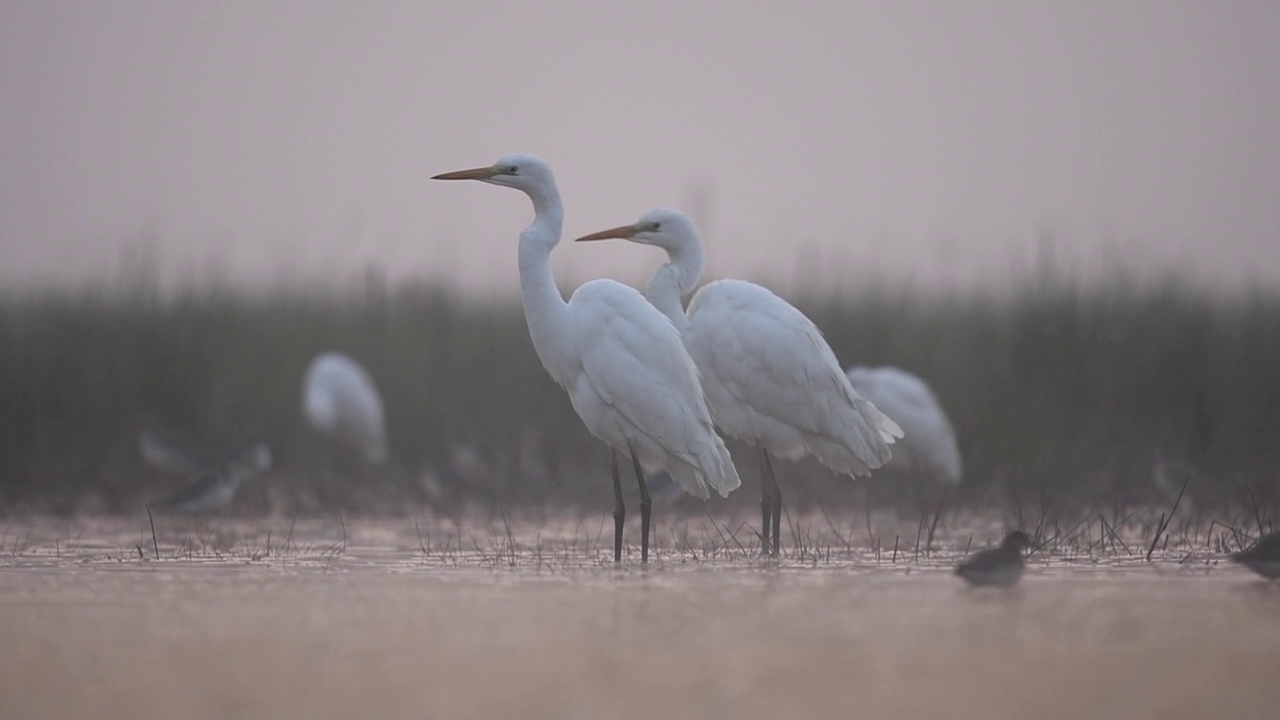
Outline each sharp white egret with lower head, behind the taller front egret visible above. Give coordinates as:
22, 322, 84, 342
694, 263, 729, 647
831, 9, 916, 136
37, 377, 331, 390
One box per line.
577, 209, 902, 553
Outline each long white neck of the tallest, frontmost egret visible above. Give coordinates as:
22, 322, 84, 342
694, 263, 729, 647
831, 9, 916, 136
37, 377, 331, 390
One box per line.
520, 184, 573, 384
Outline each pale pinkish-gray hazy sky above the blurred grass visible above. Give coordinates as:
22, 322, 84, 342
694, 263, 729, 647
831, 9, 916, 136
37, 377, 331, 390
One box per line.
0, 0, 1280, 294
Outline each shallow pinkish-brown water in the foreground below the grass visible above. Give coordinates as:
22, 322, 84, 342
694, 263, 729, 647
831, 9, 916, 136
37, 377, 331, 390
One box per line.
0, 518, 1280, 719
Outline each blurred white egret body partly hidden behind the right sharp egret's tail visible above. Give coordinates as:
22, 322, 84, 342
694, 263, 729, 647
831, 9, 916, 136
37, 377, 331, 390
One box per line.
846, 365, 964, 486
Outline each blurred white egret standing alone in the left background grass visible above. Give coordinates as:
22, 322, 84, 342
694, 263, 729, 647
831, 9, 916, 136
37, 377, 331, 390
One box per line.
302, 352, 387, 464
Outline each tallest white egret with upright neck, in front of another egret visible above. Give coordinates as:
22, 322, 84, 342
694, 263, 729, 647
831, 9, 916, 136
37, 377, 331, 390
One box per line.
433, 155, 741, 562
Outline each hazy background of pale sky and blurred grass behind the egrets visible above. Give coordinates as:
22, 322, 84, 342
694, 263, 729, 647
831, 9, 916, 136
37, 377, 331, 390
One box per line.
0, 0, 1280, 520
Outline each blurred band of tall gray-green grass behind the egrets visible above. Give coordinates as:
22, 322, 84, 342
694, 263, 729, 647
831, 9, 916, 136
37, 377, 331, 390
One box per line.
0, 271, 1280, 512
